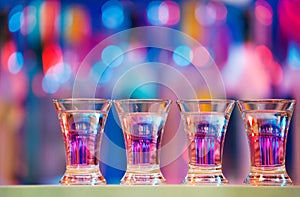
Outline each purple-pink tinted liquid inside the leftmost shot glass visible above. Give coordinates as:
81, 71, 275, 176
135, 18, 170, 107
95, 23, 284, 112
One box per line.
60, 111, 106, 168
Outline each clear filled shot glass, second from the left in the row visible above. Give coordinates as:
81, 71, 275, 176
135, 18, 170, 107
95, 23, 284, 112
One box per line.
114, 99, 171, 185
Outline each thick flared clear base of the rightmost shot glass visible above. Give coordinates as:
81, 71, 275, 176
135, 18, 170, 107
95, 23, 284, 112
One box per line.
244, 166, 293, 186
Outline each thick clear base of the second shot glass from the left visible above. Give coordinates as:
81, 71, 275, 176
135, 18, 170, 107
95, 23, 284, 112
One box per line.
121, 172, 166, 185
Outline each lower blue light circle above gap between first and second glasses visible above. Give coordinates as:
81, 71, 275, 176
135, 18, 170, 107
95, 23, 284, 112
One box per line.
101, 45, 124, 67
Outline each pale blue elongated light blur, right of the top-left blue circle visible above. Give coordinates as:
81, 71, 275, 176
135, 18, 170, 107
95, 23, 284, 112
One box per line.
21, 6, 37, 35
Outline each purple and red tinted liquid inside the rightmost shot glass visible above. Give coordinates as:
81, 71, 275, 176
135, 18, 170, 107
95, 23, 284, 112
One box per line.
246, 111, 290, 167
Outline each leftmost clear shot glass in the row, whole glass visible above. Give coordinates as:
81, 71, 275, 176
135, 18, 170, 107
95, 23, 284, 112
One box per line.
53, 98, 112, 185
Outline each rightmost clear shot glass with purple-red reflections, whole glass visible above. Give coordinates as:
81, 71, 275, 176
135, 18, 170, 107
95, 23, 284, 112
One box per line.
238, 99, 296, 186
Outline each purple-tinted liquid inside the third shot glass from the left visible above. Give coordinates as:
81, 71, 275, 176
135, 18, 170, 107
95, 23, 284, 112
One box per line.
182, 113, 227, 166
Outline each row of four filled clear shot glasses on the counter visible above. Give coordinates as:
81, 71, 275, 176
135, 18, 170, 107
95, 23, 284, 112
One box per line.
53, 98, 296, 186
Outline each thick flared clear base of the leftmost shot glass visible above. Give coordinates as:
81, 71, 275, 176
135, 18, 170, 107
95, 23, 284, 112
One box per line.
59, 166, 106, 185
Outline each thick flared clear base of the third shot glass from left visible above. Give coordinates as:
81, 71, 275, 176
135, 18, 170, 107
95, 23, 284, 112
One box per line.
182, 165, 229, 185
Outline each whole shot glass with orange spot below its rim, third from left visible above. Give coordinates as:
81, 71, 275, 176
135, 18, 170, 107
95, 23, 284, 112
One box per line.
177, 99, 235, 185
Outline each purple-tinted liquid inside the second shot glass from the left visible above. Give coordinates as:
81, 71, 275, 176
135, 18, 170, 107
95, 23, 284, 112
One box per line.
121, 113, 166, 169
